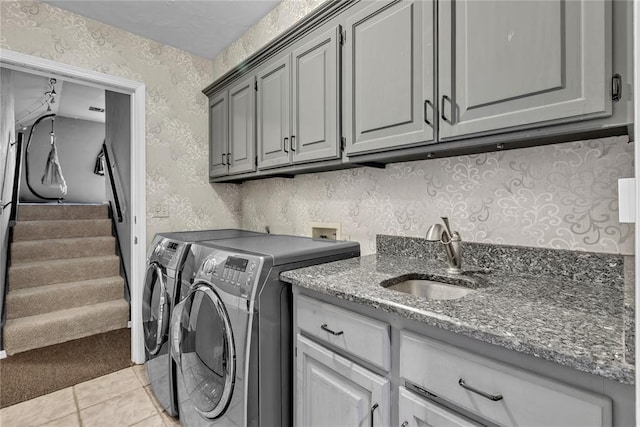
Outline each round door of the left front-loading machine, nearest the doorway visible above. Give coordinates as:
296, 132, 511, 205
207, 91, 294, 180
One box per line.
142, 262, 170, 356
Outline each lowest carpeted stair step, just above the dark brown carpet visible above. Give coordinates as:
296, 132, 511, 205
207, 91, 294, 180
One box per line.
4, 299, 129, 355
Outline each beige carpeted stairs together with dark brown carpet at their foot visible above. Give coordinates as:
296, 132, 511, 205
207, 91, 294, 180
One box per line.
0, 204, 131, 407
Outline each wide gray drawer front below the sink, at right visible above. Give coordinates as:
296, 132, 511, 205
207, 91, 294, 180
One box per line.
400, 332, 612, 426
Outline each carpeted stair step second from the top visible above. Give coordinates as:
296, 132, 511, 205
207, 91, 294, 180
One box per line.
13, 219, 111, 242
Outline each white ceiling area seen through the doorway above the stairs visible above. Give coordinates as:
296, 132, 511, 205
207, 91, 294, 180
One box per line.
13, 71, 105, 127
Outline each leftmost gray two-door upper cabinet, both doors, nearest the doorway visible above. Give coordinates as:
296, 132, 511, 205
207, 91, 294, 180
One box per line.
209, 76, 256, 178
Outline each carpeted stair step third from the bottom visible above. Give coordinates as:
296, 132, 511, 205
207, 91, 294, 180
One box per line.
8, 255, 120, 290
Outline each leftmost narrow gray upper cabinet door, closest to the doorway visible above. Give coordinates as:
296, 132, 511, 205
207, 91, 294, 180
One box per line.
209, 90, 229, 177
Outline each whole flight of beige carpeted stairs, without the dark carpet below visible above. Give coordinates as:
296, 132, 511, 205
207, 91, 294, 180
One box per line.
4, 204, 129, 356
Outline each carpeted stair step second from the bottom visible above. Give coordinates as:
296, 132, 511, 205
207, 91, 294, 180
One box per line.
6, 276, 124, 319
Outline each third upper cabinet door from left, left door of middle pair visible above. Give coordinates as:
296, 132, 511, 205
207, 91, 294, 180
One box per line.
258, 55, 291, 169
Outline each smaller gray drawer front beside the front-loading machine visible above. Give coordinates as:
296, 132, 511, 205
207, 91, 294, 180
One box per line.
296, 295, 391, 371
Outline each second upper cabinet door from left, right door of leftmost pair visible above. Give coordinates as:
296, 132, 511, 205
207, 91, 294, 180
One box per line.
229, 76, 256, 174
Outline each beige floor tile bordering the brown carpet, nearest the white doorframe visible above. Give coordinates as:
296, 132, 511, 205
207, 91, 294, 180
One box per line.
73, 368, 142, 409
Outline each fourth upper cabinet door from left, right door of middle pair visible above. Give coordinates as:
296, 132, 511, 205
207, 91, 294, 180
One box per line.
291, 28, 340, 163
